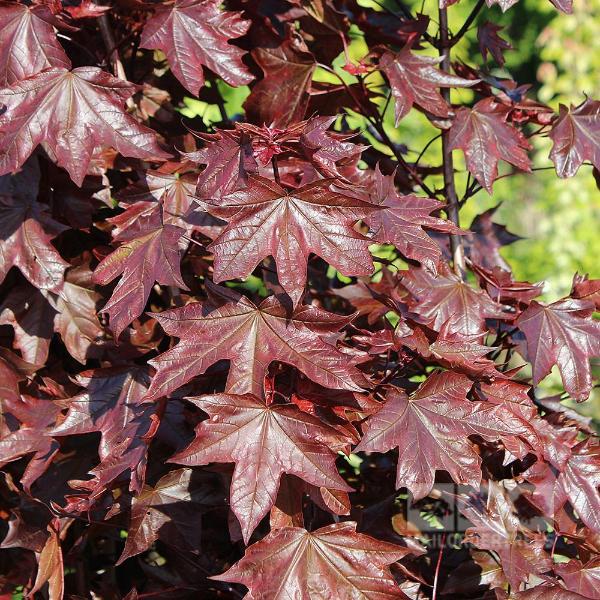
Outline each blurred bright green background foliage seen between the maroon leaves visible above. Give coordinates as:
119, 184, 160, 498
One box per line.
180, 0, 600, 423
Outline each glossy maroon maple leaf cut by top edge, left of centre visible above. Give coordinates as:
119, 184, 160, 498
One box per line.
141, 0, 253, 95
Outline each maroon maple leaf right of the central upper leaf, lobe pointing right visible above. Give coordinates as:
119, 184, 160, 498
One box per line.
367, 165, 463, 270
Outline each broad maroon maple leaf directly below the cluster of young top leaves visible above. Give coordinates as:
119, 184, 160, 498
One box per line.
207, 176, 377, 302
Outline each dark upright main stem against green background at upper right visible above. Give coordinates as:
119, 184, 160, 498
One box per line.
439, 8, 465, 277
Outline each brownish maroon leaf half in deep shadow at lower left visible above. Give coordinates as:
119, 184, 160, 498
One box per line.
117, 469, 225, 565
